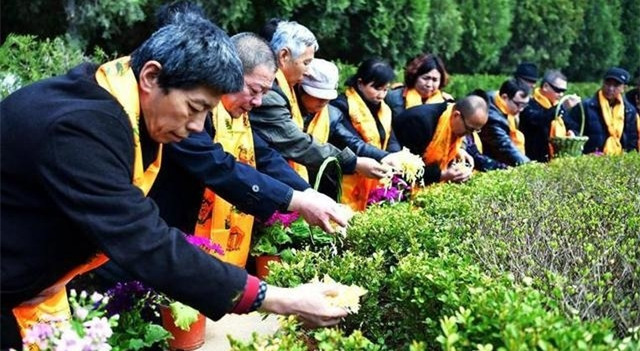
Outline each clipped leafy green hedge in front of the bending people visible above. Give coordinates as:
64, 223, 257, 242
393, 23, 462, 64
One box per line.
232, 153, 640, 350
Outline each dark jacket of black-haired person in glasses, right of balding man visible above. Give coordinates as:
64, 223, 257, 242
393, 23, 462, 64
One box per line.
480, 97, 530, 166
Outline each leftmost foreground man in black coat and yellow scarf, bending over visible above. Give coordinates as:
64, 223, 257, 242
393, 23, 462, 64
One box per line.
0, 17, 346, 348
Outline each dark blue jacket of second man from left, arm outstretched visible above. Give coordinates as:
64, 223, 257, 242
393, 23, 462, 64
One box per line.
149, 118, 309, 233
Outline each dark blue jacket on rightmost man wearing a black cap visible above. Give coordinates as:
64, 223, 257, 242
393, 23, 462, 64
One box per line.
565, 93, 638, 154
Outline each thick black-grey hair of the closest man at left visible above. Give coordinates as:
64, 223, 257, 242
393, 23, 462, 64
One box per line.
131, 14, 244, 94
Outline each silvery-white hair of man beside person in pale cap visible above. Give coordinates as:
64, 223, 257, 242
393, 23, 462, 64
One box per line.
270, 21, 318, 59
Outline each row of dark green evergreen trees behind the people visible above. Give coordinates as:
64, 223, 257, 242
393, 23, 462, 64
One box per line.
1, 0, 640, 81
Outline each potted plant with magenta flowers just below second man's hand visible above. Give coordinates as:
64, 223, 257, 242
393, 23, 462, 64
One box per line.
251, 211, 335, 279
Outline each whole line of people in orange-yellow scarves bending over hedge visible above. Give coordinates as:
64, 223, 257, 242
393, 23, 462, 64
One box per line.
0, 2, 640, 348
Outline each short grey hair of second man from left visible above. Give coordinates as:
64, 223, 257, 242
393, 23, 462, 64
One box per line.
231, 32, 278, 74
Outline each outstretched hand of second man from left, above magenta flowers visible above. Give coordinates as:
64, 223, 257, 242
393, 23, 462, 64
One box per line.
287, 188, 353, 233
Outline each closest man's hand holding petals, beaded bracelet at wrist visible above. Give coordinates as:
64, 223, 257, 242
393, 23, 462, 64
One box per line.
260, 283, 347, 328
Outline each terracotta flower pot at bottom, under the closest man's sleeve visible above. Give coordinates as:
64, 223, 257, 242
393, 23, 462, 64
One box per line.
160, 306, 207, 351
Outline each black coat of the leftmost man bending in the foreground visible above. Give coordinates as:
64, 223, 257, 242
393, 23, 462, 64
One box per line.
0, 64, 252, 345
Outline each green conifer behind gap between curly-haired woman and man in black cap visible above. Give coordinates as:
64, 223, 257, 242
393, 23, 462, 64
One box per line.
449, 0, 514, 73
